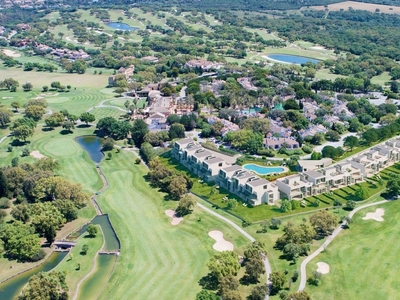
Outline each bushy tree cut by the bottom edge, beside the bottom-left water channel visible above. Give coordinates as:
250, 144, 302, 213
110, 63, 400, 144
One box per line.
18, 271, 68, 300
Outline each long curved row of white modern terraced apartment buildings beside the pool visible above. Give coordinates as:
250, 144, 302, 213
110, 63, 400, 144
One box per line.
171, 137, 400, 206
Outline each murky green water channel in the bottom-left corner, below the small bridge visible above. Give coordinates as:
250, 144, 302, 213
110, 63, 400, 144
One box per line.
0, 252, 68, 299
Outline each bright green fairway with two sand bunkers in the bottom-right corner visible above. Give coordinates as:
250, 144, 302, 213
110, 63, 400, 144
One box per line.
306, 200, 400, 299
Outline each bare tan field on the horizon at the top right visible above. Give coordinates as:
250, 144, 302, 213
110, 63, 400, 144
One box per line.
310, 1, 400, 14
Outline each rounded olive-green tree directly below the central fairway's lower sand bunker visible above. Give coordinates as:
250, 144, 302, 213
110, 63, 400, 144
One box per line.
207, 251, 240, 279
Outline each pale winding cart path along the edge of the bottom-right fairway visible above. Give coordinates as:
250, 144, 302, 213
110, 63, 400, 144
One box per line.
298, 200, 390, 291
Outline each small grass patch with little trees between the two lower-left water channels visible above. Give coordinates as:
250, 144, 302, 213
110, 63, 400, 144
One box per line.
55, 226, 103, 297
